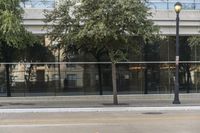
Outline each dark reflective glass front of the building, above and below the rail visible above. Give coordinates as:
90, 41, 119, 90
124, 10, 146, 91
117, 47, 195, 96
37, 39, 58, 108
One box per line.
0, 36, 200, 96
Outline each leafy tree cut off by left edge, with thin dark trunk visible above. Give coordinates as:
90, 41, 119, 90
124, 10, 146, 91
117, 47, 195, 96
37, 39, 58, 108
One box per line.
0, 0, 34, 96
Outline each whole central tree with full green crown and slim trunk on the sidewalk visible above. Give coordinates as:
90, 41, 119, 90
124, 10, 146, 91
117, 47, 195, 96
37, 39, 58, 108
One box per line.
46, 0, 156, 104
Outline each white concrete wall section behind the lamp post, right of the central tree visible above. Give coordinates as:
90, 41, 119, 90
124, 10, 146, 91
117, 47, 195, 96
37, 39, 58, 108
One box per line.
152, 10, 200, 35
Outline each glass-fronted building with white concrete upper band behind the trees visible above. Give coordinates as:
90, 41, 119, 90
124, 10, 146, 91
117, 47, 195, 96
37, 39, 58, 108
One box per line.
0, 0, 200, 96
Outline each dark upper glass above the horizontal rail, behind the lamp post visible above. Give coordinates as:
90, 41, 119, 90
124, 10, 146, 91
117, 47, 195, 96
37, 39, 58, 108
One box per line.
129, 36, 194, 62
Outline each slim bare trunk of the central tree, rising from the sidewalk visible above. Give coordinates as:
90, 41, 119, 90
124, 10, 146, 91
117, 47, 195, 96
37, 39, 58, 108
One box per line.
112, 63, 118, 105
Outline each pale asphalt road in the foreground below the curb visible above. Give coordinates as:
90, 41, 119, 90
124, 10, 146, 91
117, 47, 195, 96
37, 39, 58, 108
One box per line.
0, 111, 200, 133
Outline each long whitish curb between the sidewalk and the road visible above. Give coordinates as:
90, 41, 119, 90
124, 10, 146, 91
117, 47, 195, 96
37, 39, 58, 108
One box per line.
0, 106, 200, 113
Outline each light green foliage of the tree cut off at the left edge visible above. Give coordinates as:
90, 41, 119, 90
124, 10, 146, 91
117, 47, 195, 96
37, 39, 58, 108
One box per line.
0, 0, 34, 48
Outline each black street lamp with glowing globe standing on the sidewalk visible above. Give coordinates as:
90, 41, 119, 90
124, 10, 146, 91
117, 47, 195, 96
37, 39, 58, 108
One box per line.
173, 2, 182, 104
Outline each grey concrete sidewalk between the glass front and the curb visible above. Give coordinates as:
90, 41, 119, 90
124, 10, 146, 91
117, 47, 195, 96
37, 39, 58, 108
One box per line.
0, 93, 200, 109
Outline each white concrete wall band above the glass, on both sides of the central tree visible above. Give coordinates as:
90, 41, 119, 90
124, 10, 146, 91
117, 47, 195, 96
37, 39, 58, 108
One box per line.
24, 9, 200, 35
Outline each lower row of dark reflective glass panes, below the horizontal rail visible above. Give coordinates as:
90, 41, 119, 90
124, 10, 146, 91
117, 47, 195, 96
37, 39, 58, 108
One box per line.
0, 61, 200, 96
